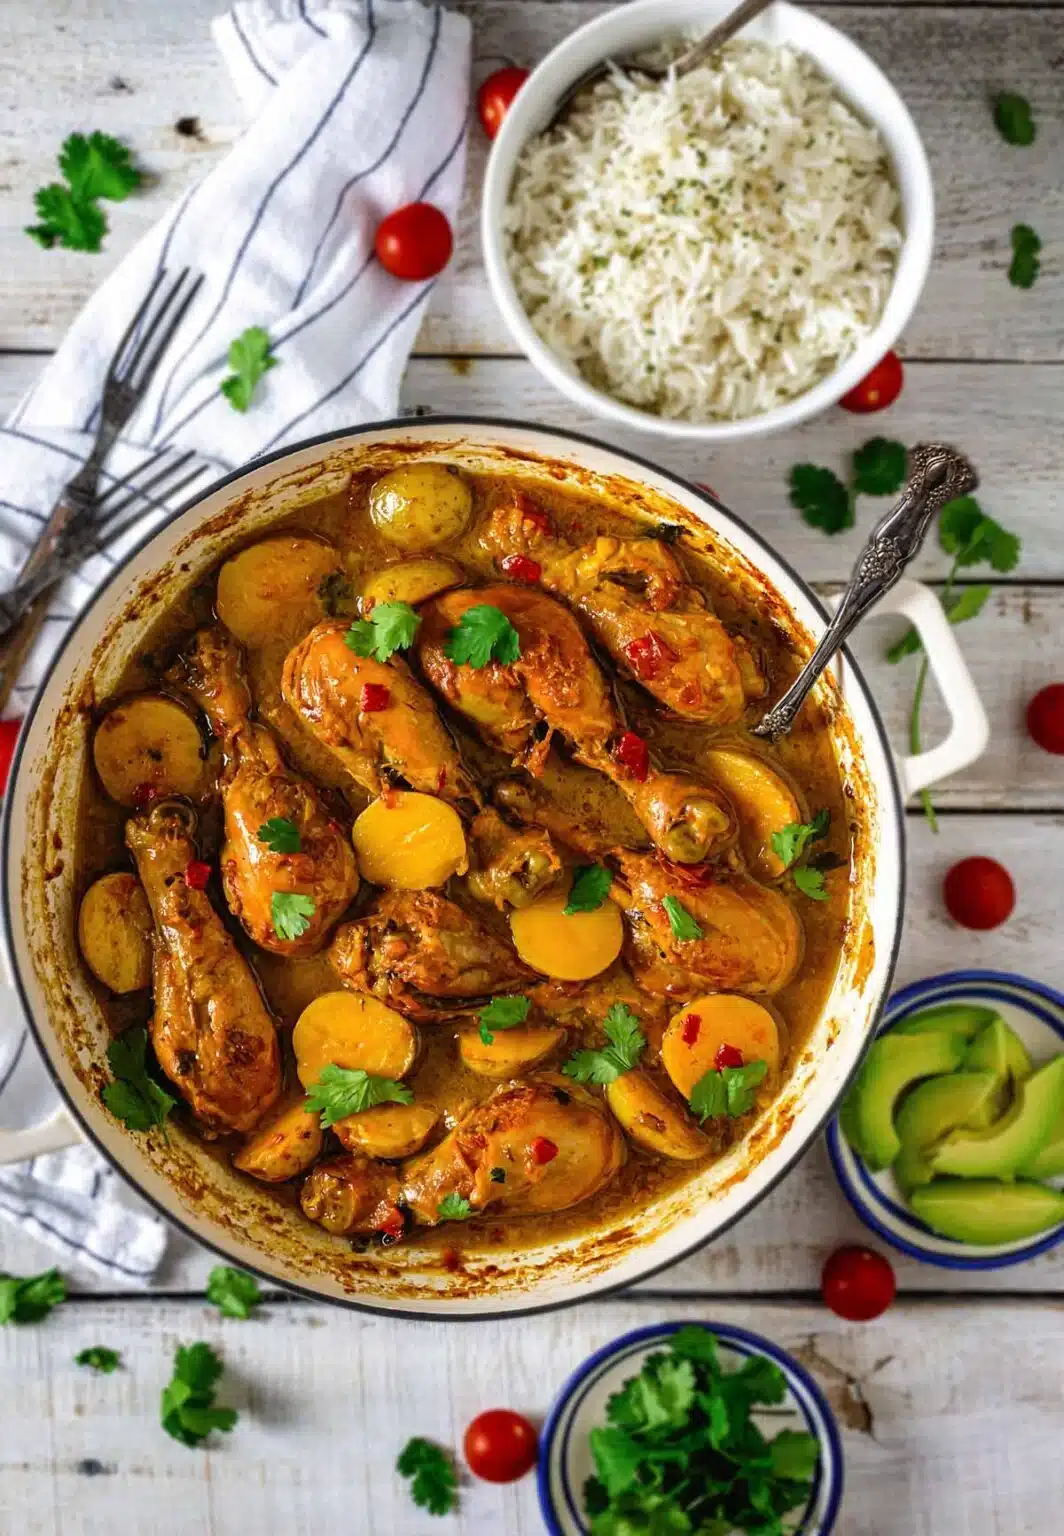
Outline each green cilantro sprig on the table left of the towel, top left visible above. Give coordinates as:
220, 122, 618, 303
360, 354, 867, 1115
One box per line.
26, 134, 141, 250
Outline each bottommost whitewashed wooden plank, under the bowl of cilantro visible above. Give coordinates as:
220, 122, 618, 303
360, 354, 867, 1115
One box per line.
0, 1298, 1064, 1536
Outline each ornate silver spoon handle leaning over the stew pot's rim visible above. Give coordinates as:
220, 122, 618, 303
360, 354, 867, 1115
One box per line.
754, 442, 978, 742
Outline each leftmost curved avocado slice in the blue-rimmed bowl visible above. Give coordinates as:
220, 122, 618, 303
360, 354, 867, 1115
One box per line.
841, 1029, 966, 1172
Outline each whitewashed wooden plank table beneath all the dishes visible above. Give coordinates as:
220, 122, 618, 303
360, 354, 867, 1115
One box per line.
0, 0, 1064, 1536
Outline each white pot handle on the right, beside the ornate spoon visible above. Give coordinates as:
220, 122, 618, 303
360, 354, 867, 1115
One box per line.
853, 576, 990, 796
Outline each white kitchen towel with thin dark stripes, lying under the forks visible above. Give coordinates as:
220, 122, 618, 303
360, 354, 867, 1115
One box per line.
0, 0, 470, 1278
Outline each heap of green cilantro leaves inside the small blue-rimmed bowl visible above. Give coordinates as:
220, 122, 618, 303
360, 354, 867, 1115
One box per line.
583, 1326, 818, 1536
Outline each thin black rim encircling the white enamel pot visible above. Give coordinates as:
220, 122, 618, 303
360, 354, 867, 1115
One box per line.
0, 415, 906, 1322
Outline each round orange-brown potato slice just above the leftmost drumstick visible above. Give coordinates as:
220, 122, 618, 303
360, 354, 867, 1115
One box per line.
92, 693, 204, 806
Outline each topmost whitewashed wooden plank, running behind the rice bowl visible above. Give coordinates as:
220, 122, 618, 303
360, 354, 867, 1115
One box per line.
0, 0, 1064, 359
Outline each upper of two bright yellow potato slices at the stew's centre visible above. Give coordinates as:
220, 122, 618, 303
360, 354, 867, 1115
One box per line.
352, 790, 470, 891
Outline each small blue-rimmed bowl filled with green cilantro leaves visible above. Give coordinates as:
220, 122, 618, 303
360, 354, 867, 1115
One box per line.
539, 1322, 843, 1536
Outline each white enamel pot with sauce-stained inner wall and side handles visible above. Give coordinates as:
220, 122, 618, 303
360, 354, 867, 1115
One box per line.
0, 418, 986, 1318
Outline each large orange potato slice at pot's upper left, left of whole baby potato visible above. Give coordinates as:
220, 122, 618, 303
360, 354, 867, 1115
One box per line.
215, 533, 341, 645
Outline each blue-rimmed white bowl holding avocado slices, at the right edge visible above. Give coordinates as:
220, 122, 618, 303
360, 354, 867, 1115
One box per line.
828, 971, 1064, 1270
